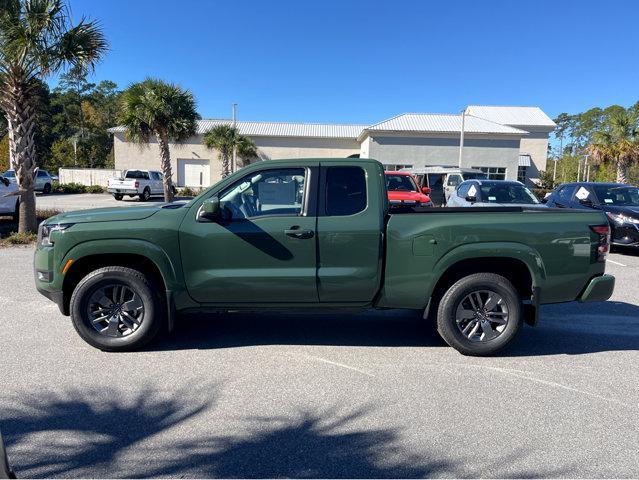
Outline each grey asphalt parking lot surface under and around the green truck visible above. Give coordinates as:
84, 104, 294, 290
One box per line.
0, 248, 639, 478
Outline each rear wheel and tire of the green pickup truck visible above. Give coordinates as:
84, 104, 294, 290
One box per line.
437, 273, 523, 356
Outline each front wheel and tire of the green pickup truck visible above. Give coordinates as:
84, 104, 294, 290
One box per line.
69, 266, 166, 352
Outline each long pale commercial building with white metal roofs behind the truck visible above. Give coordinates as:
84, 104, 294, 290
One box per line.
110, 105, 555, 187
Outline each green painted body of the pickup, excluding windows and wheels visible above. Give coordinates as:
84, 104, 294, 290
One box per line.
34, 159, 614, 320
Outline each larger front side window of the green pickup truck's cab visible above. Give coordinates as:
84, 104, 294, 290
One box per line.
220, 168, 306, 219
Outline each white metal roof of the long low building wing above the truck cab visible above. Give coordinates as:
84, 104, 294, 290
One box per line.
109, 119, 366, 140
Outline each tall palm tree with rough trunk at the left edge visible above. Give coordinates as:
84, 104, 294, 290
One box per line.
0, 0, 107, 232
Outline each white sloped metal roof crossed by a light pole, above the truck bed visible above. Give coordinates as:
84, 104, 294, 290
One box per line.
364, 113, 528, 136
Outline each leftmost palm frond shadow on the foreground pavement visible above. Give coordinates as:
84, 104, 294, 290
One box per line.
0, 387, 214, 477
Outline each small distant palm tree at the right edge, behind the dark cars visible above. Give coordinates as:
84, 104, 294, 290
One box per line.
588, 111, 639, 183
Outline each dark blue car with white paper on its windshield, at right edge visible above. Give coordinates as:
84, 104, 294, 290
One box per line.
546, 182, 639, 247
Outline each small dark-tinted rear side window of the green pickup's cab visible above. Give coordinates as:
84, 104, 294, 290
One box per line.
326, 167, 366, 216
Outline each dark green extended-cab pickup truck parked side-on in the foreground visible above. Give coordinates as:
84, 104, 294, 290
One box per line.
35, 158, 614, 355
